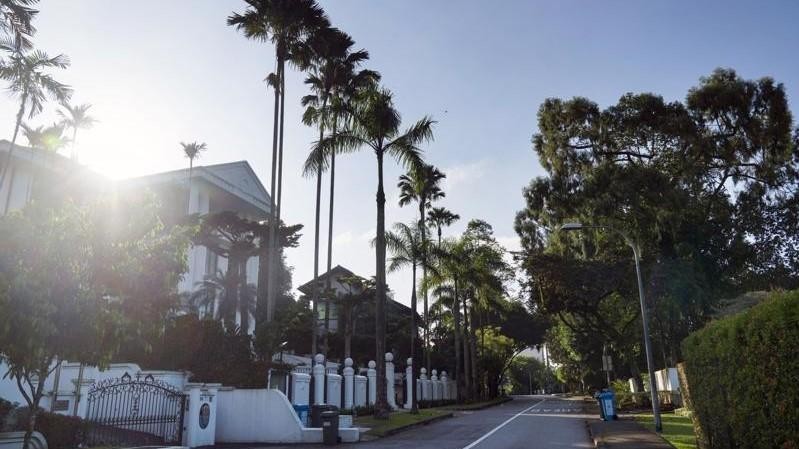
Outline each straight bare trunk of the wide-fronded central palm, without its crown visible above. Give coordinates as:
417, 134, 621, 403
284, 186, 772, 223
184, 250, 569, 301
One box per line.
375, 149, 389, 419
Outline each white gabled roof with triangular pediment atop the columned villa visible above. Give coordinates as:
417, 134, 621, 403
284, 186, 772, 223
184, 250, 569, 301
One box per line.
125, 161, 272, 214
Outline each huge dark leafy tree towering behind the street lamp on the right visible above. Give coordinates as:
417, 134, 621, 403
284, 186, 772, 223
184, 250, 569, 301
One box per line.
516, 69, 799, 382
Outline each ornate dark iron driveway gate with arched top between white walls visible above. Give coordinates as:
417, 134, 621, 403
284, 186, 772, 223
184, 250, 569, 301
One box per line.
85, 373, 186, 446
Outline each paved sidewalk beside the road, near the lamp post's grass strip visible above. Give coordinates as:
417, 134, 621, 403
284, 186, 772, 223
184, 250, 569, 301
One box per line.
588, 418, 674, 449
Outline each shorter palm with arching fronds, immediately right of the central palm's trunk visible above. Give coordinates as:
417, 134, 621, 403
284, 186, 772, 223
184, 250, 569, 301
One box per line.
386, 223, 425, 414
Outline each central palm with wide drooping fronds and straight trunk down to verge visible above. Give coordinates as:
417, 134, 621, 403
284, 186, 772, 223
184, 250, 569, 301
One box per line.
304, 88, 434, 418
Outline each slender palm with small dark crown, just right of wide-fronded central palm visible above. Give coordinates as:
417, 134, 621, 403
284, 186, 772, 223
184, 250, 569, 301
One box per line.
397, 164, 447, 369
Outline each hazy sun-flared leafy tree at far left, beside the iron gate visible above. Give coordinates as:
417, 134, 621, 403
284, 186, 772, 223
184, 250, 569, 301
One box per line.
0, 203, 188, 445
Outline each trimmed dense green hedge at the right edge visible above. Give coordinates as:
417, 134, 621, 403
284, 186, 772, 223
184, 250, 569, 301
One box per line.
682, 291, 799, 449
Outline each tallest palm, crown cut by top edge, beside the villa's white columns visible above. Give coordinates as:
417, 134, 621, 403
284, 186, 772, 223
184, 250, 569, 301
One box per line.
227, 0, 330, 321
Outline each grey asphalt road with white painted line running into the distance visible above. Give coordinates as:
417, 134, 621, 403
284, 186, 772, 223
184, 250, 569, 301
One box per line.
219, 396, 593, 449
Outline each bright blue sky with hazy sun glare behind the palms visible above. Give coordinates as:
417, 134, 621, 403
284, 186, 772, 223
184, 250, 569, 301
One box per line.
0, 0, 799, 304
